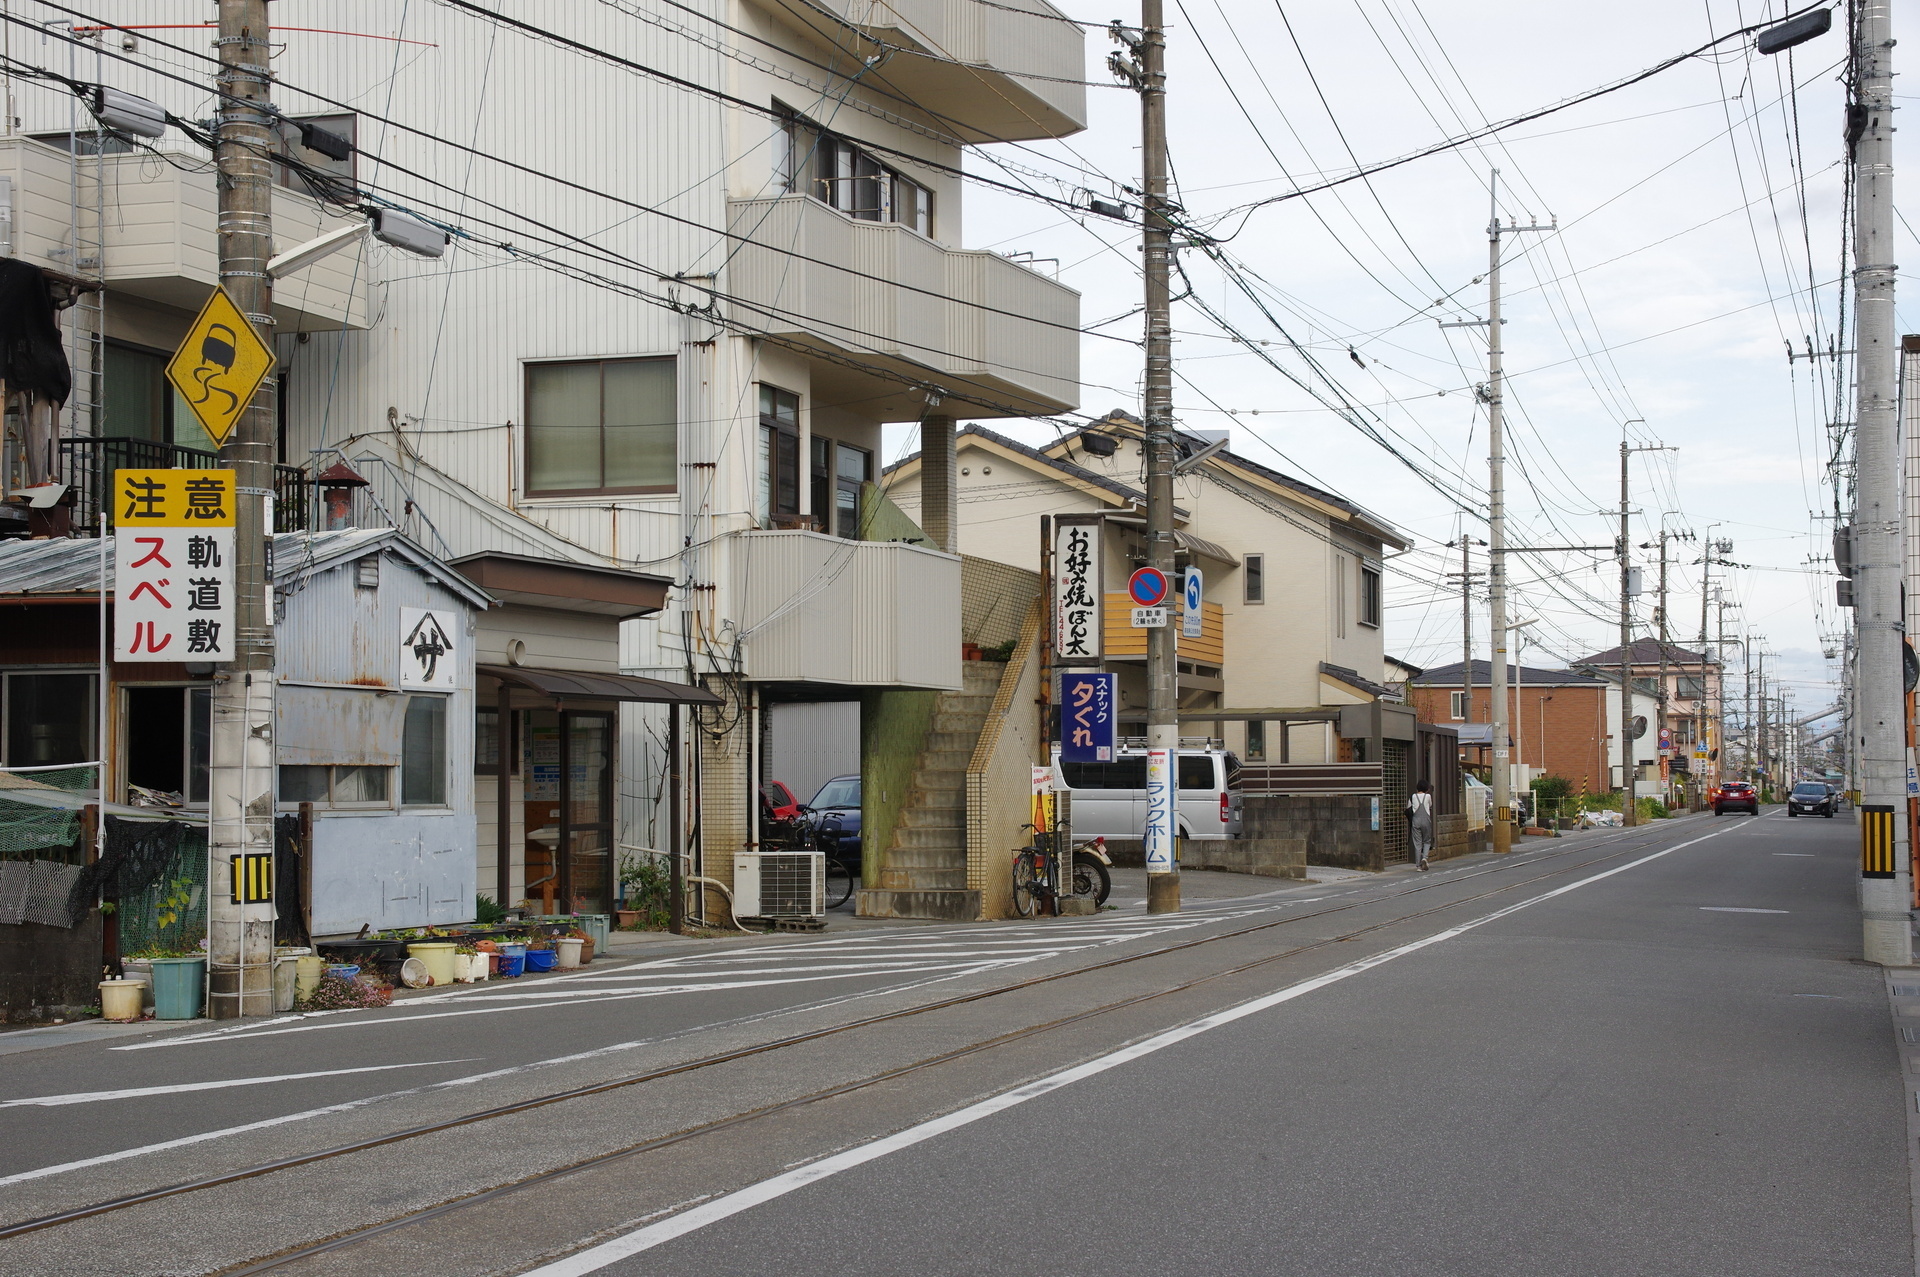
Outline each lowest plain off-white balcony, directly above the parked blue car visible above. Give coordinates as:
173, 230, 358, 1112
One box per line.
732, 532, 962, 689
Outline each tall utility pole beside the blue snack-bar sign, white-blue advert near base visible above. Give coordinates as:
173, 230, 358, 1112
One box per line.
1139, 0, 1181, 914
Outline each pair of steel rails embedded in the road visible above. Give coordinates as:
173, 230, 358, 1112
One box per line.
0, 830, 1712, 1244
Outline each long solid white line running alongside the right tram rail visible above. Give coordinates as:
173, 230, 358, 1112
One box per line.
522, 831, 1743, 1277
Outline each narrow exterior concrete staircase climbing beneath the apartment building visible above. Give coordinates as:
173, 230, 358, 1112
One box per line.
860, 661, 1006, 922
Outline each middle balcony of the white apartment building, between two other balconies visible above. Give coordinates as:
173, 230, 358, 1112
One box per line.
724, 196, 1079, 421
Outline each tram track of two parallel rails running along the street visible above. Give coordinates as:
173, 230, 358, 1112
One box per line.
0, 818, 1712, 1252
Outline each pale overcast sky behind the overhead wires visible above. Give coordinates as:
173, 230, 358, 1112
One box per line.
921, 0, 1896, 711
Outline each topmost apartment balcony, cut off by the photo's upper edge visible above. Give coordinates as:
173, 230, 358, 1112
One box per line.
768, 0, 1087, 142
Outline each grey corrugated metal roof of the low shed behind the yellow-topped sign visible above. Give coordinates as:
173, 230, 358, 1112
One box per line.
0, 528, 492, 607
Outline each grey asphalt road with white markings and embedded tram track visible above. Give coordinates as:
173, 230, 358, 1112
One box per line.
0, 814, 1920, 1277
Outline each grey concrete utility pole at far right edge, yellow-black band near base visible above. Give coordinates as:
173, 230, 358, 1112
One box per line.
1847, 0, 1912, 966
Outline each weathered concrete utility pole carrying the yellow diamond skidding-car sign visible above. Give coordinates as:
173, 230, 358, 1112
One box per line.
207, 0, 278, 1020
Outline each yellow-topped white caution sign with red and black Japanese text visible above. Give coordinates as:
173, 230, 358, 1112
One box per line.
111, 470, 234, 663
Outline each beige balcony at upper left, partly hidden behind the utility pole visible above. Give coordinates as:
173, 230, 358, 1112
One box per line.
0, 138, 369, 334
